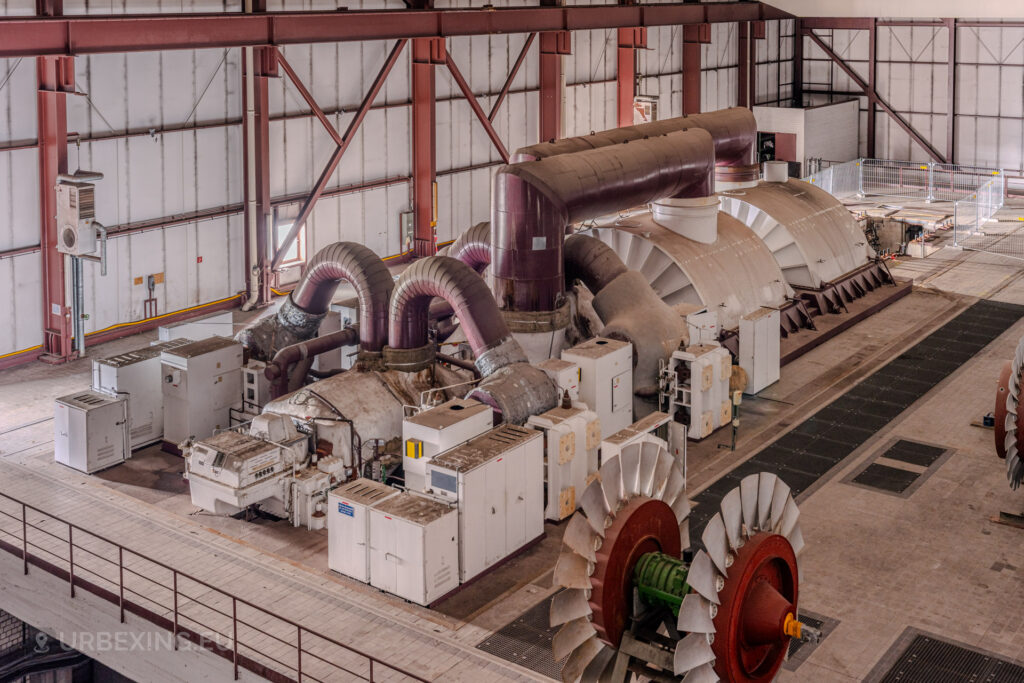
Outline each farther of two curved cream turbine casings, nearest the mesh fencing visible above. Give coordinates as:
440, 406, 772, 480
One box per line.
719, 179, 874, 289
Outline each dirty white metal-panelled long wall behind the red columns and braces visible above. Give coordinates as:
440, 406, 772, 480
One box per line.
0, 0, 792, 355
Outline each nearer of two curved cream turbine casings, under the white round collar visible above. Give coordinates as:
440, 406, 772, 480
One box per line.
589, 211, 793, 329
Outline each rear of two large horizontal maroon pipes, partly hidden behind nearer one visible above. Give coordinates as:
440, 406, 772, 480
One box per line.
511, 106, 758, 166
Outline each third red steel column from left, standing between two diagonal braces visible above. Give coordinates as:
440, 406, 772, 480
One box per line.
412, 38, 446, 256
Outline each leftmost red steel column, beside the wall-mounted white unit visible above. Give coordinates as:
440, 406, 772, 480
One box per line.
36, 0, 75, 364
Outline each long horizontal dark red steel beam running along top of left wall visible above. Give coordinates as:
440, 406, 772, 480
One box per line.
0, 2, 793, 57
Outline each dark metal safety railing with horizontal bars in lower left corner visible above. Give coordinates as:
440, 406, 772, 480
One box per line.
0, 494, 426, 683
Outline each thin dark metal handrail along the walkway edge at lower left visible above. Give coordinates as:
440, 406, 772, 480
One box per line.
0, 493, 427, 683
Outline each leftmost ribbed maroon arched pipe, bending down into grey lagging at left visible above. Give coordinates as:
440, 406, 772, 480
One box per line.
290, 242, 394, 352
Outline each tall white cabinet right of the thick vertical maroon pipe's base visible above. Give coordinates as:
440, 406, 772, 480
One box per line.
562, 337, 633, 434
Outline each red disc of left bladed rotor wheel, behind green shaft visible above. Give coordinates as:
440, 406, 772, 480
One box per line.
590, 497, 682, 648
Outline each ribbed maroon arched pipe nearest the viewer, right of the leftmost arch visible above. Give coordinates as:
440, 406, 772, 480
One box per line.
388, 256, 511, 358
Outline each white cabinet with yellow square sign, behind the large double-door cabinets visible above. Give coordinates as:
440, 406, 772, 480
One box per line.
401, 398, 494, 493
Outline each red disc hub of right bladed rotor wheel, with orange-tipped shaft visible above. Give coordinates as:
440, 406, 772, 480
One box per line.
712, 532, 799, 683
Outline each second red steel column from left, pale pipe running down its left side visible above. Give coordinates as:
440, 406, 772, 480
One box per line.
242, 47, 278, 307
